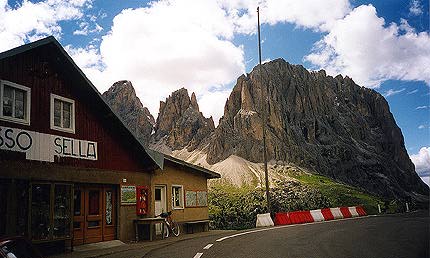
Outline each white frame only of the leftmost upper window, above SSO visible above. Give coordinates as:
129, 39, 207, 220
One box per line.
0, 80, 31, 125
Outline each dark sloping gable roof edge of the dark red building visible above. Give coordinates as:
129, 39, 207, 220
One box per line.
0, 36, 163, 170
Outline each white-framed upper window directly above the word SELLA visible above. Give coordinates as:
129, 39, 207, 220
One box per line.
51, 94, 75, 133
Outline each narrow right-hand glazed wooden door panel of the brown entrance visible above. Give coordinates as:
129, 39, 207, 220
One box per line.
103, 186, 116, 241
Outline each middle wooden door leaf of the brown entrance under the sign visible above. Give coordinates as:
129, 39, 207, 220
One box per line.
84, 186, 103, 244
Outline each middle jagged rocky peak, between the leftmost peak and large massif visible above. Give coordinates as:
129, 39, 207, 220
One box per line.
154, 88, 215, 151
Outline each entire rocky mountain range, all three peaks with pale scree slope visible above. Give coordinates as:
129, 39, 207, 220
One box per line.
103, 59, 429, 202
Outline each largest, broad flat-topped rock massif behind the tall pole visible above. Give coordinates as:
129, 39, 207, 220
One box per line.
207, 59, 429, 202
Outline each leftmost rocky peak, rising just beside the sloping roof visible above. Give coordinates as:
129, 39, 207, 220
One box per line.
103, 81, 155, 145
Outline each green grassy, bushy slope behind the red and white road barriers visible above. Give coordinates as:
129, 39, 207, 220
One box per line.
209, 169, 388, 229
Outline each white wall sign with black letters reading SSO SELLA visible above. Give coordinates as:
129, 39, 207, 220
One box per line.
0, 126, 98, 162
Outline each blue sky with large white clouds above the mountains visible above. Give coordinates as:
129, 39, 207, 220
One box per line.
0, 0, 430, 183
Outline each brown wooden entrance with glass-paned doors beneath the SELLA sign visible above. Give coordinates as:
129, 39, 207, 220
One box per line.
73, 185, 116, 245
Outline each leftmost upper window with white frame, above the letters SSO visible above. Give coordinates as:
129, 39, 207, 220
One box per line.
0, 81, 31, 125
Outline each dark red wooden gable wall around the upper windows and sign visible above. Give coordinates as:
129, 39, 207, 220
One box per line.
0, 44, 147, 171
